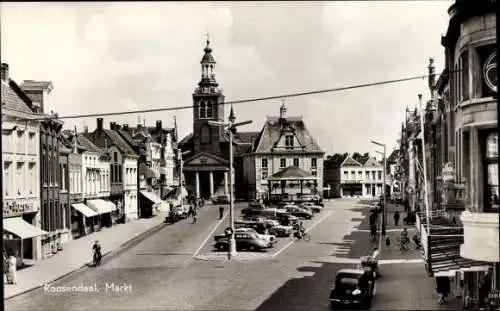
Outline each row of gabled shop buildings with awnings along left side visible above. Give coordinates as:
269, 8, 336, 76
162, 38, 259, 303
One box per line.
1, 64, 178, 261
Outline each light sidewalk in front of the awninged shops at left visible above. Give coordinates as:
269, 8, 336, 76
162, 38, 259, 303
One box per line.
4, 212, 172, 300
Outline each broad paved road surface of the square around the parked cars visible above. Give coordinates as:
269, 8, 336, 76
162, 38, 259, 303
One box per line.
6, 200, 458, 311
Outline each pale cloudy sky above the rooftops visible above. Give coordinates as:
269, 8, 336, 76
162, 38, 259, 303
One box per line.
0, 1, 452, 155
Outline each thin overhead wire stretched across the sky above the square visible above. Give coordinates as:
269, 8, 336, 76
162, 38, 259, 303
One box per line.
3, 68, 458, 121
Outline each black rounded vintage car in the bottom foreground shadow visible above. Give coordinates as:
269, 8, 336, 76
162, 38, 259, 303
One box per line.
330, 269, 375, 310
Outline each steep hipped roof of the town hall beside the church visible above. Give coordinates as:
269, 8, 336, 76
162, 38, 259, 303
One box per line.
254, 117, 323, 153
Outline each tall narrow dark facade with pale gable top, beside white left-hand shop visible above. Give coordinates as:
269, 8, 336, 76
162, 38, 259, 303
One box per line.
20, 80, 65, 258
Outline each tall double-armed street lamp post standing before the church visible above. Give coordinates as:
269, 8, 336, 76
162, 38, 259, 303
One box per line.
208, 106, 252, 259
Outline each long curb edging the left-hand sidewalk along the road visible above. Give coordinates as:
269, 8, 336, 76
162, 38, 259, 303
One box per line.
3, 222, 168, 302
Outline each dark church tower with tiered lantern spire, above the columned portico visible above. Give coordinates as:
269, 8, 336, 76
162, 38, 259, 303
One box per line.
193, 35, 224, 155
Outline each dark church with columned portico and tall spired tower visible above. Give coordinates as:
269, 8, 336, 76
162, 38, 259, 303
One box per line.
179, 40, 253, 199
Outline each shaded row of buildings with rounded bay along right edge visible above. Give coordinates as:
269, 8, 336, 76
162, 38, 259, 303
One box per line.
400, 0, 500, 308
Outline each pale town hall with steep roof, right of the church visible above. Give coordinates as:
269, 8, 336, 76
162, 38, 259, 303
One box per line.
243, 103, 324, 199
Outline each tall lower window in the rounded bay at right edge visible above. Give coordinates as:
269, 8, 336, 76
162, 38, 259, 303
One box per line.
480, 131, 499, 212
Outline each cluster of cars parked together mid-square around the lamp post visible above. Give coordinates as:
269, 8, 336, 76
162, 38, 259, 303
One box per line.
214, 202, 323, 251
